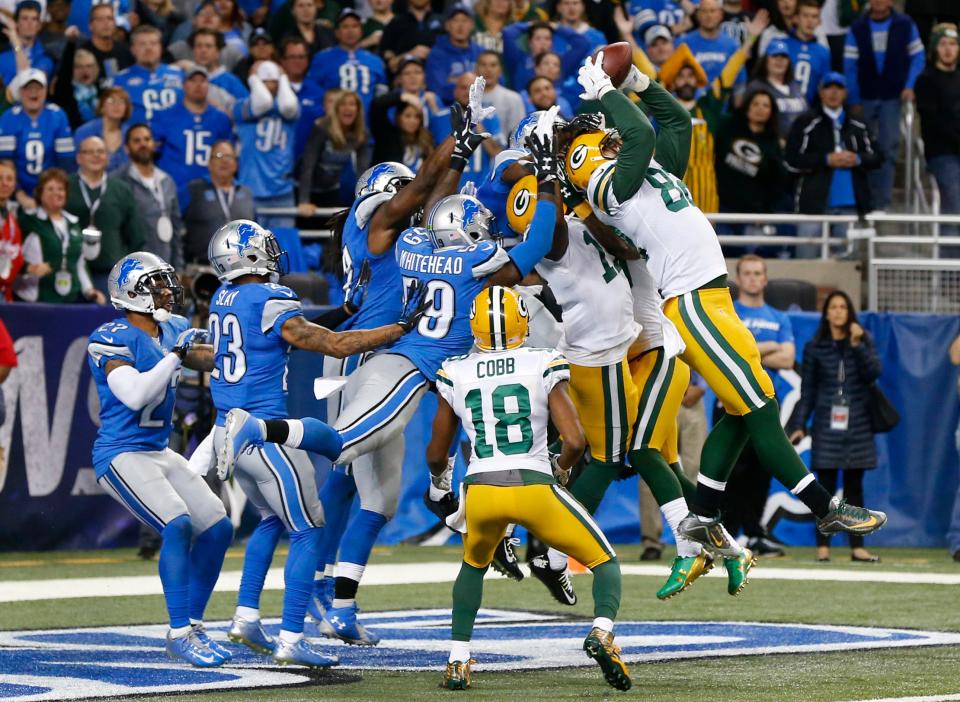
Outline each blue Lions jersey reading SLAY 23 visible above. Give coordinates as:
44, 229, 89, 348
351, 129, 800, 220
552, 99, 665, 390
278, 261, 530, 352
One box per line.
208, 283, 303, 425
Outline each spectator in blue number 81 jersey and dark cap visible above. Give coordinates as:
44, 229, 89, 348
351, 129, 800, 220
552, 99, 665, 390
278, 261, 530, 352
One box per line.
306, 8, 387, 115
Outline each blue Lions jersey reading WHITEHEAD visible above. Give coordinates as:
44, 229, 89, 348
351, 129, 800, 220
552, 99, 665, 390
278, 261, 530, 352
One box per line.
390, 227, 510, 380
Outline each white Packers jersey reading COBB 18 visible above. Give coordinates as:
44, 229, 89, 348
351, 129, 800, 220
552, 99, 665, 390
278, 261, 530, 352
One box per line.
437, 346, 570, 482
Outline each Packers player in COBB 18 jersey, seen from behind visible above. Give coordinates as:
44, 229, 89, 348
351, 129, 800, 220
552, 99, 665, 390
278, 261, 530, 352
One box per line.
427, 285, 631, 690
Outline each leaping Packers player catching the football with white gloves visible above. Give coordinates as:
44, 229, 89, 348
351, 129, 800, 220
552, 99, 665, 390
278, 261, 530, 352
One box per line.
566, 53, 886, 557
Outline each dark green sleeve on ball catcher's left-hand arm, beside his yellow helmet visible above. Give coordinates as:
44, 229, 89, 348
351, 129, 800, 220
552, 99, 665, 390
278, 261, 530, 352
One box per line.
600, 90, 652, 202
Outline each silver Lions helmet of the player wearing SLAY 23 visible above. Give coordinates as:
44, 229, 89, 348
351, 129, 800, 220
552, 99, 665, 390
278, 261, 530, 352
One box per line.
207, 219, 286, 282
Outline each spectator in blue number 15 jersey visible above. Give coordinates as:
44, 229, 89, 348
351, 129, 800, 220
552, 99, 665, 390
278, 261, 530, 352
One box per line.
153, 64, 233, 210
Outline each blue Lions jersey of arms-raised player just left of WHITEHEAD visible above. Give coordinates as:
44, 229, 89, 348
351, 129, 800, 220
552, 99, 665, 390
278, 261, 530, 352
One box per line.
340, 193, 403, 329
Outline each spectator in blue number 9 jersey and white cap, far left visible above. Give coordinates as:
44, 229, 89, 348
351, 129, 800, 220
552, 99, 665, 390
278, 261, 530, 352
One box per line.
0, 68, 76, 208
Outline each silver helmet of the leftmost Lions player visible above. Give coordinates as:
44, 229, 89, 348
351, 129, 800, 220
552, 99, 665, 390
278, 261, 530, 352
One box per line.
107, 251, 183, 322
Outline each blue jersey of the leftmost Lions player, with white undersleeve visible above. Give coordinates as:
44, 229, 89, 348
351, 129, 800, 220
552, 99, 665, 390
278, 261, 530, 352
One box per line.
87, 315, 190, 478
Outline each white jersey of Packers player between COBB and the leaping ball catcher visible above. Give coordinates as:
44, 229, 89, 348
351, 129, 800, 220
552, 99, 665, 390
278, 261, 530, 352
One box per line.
537, 217, 640, 368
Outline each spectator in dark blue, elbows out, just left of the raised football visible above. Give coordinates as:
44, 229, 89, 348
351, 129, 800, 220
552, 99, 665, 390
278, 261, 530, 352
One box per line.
503, 22, 591, 90
